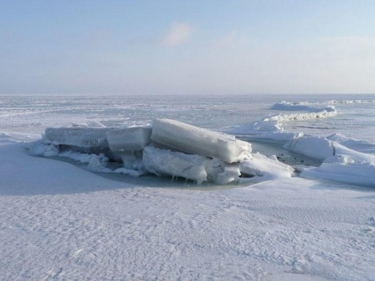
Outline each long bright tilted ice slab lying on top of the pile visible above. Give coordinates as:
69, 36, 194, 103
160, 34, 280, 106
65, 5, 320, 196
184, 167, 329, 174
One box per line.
151, 119, 251, 163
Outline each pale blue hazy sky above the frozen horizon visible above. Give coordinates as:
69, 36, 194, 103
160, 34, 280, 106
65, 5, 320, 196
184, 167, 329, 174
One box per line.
0, 0, 375, 95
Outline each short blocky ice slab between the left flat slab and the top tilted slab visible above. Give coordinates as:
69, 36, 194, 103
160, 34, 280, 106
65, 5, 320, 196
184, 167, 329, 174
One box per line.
106, 127, 151, 151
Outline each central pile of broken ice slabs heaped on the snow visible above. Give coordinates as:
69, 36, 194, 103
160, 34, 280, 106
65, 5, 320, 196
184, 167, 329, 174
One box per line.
32, 119, 294, 184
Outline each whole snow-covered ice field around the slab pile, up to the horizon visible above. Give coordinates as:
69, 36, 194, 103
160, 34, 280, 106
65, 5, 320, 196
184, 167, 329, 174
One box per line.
0, 95, 375, 281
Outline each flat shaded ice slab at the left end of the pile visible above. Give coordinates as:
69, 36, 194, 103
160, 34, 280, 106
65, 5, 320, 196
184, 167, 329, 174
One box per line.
45, 128, 112, 148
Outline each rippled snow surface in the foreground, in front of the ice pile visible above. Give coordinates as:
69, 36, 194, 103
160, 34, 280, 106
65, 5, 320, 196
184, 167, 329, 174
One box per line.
0, 139, 375, 281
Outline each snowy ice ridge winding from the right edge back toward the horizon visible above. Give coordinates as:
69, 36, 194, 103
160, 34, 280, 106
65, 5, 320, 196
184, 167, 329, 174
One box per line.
225, 101, 375, 187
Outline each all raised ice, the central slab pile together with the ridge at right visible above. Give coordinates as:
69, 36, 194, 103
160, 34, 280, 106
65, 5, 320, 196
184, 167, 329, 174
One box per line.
26, 97, 375, 188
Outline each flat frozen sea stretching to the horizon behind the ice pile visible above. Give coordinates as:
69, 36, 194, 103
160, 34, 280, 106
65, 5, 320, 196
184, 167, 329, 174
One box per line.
0, 95, 375, 142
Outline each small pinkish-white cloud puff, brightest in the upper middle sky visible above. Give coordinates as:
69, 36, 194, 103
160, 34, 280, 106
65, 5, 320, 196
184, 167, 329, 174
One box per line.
161, 22, 193, 46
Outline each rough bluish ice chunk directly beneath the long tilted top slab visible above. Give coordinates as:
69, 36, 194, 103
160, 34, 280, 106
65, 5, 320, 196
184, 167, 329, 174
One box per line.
142, 147, 209, 184
